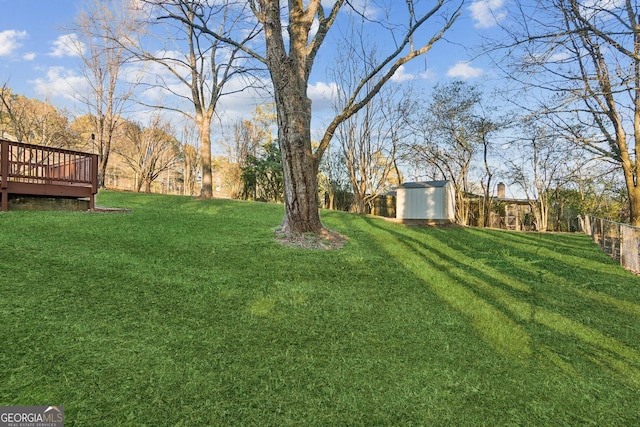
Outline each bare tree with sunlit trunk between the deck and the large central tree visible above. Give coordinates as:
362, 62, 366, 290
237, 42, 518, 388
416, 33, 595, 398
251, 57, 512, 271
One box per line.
126, 0, 258, 198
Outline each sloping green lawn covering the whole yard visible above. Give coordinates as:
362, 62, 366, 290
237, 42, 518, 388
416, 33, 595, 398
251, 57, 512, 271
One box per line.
0, 192, 640, 427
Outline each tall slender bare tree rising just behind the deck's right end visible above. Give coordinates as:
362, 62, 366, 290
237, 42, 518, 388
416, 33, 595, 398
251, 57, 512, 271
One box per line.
71, 0, 136, 188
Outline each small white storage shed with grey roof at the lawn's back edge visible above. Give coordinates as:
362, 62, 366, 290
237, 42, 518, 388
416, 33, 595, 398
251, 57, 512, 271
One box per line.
396, 181, 456, 223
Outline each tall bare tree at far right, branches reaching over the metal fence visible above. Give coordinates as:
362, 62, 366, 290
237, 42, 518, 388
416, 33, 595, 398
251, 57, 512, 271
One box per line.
492, 0, 640, 225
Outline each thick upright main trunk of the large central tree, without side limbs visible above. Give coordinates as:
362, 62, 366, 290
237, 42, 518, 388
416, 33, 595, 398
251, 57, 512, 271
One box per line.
260, 0, 324, 236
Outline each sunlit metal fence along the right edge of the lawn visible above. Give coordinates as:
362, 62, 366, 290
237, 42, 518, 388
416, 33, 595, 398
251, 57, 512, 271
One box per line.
580, 216, 640, 273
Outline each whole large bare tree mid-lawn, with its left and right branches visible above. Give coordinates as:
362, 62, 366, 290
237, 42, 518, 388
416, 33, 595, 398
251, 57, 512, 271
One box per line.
166, 0, 461, 236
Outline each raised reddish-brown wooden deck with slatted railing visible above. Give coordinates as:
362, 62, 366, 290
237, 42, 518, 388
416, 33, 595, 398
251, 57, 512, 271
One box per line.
0, 140, 98, 211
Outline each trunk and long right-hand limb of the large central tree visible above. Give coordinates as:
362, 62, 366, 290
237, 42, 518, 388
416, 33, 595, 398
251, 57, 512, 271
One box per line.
251, 0, 461, 235
